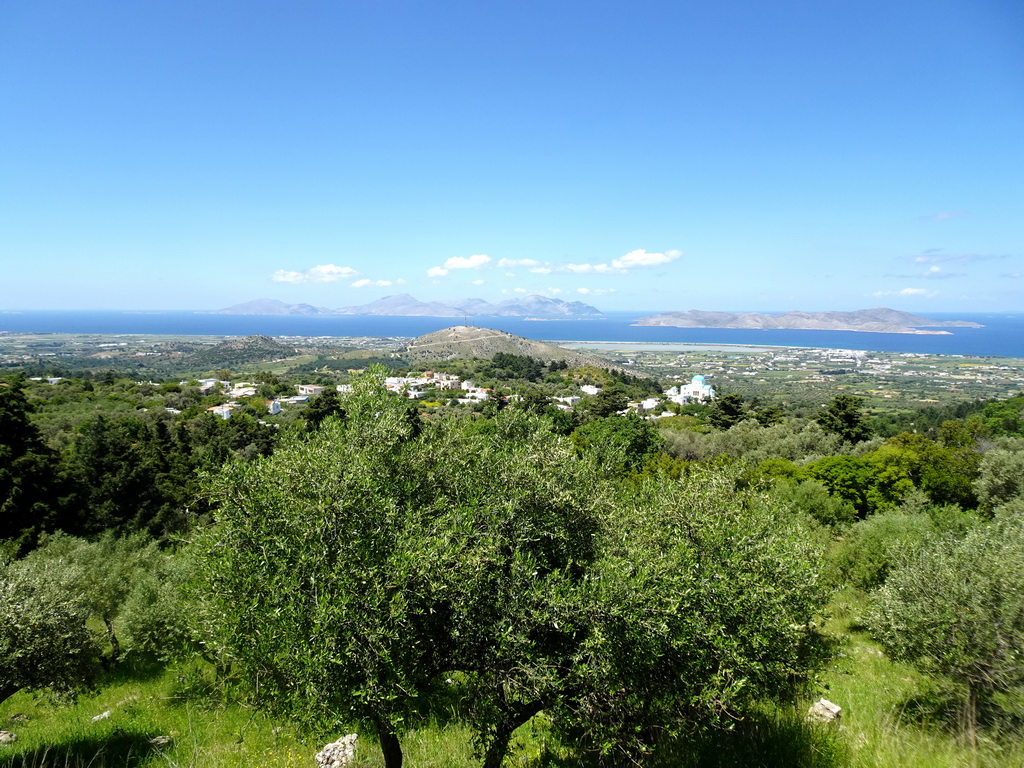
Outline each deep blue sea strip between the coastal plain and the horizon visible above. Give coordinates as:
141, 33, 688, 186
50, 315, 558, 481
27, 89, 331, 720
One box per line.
0, 310, 1024, 358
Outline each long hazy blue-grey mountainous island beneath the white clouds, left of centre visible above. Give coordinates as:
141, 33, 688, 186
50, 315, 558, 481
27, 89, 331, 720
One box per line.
207, 293, 604, 319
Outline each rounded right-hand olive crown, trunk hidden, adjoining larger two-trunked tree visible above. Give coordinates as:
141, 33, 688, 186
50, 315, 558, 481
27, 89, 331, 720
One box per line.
553, 469, 828, 762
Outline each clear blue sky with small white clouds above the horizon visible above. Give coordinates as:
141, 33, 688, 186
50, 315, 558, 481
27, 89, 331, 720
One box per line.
0, 0, 1024, 313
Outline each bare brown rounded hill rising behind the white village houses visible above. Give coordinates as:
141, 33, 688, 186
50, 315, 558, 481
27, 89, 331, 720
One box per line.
401, 326, 609, 368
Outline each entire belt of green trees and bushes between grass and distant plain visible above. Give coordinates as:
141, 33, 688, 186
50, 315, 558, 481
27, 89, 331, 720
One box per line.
6, 349, 1024, 768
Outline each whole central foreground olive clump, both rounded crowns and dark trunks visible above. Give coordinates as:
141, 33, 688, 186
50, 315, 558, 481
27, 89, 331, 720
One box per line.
191, 370, 823, 768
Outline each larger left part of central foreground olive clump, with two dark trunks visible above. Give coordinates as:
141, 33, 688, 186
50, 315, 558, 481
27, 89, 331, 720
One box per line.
193, 377, 594, 768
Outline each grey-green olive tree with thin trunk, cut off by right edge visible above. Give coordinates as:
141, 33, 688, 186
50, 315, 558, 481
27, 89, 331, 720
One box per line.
868, 515, 1024, 743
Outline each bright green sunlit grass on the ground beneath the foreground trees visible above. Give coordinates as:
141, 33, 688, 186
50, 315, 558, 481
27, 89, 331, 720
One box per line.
6, 606, 1024, 768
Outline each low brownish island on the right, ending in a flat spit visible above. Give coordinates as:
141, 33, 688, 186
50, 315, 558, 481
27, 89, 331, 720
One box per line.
633, 307, 984, 334
